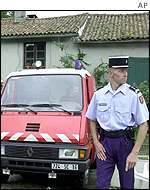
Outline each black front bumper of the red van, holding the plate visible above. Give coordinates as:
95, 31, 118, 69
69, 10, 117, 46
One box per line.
1, 156, 90, 175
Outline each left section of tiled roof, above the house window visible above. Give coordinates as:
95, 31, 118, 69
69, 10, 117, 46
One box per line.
1, 14, 88, 37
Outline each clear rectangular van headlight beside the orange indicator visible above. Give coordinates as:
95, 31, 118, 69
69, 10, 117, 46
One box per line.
59, 149, 79, 159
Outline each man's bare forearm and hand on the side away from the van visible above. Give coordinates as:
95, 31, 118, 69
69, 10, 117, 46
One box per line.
125, 122, 148, 171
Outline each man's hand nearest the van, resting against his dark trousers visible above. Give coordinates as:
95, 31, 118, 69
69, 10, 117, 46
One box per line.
94, 141, 106, 160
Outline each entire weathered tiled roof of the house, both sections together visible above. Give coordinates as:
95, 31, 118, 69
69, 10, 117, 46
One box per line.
1, 13, 149, 42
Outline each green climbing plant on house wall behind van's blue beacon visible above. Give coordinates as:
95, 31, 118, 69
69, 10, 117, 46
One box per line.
56, 43, 89, 68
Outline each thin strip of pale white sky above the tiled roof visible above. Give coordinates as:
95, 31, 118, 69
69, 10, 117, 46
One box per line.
26, 10, 147, 18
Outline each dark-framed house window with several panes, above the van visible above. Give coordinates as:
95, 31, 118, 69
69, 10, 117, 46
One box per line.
24, 42, 46, 69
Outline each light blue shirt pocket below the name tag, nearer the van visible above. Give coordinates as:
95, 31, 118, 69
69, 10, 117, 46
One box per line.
97, 106, 110, 122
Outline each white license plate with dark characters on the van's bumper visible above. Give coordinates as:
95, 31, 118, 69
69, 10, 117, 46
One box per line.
51, 163, 78, 170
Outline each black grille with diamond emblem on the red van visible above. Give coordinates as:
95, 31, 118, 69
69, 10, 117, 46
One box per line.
5, 145, 58, 159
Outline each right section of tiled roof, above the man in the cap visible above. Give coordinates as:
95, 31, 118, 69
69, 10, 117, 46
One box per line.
80, 13, 149, 41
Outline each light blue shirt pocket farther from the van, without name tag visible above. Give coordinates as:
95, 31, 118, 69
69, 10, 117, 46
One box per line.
115, 106, 131, 125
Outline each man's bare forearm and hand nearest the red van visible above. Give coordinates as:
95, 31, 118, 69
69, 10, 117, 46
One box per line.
90, 120, 106, 160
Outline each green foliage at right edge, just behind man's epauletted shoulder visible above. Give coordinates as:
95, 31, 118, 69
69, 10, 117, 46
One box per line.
138, 80, 149, 104
